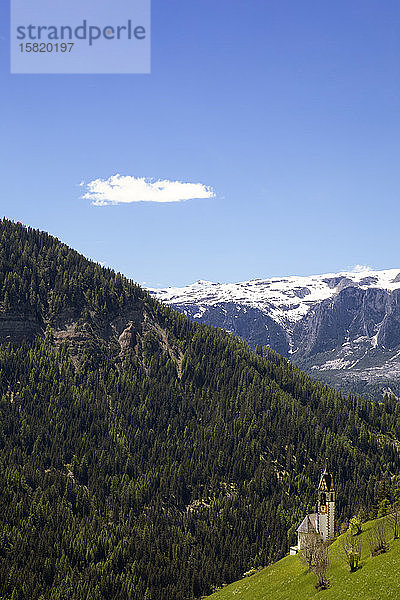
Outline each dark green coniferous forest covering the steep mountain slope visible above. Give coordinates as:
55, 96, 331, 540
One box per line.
0, 219, 400, 600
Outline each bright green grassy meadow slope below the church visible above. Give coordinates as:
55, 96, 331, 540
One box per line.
209, 521, 400, 600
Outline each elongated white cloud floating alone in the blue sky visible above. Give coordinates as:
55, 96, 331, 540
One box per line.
82, 174, 215, 206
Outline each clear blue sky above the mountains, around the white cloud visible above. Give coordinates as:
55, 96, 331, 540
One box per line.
0, 0, 400, 287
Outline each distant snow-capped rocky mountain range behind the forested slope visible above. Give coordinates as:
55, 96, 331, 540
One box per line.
150, 269, 400, 393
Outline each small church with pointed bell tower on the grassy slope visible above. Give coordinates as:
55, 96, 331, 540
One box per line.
290, 466, 335, 554
